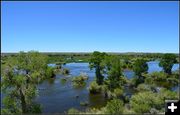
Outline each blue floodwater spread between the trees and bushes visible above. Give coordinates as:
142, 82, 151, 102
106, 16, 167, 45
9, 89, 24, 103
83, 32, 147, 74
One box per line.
36, 61, 179, 113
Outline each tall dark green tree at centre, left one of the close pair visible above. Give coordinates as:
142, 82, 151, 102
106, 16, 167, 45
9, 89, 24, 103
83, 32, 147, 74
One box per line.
89, 51, 107, 85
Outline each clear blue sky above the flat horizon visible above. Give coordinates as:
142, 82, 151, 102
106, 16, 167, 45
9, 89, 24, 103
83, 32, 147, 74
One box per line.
1, 1, 179, 53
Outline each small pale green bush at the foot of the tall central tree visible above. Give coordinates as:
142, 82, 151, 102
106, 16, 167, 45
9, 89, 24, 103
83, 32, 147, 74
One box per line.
89, 81, 101, 94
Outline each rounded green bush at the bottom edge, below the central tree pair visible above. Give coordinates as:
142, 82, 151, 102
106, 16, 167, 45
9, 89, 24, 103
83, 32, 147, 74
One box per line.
105, 99, 123, 114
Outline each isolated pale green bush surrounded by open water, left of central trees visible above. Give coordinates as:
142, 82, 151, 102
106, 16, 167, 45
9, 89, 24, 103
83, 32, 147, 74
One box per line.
72, 73, 88, 87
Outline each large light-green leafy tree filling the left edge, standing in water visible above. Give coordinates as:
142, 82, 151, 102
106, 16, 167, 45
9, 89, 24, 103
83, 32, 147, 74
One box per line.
1, 51, 47, 114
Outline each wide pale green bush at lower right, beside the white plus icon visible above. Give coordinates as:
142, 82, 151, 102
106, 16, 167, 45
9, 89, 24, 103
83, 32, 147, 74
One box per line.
130, 88, 178, 113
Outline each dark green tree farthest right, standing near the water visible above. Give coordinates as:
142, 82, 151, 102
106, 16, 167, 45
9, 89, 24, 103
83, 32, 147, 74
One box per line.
159, 53, 177, 74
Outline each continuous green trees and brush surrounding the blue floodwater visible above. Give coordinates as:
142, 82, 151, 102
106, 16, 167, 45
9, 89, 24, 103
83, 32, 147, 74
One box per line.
1, 51, 179, 114
